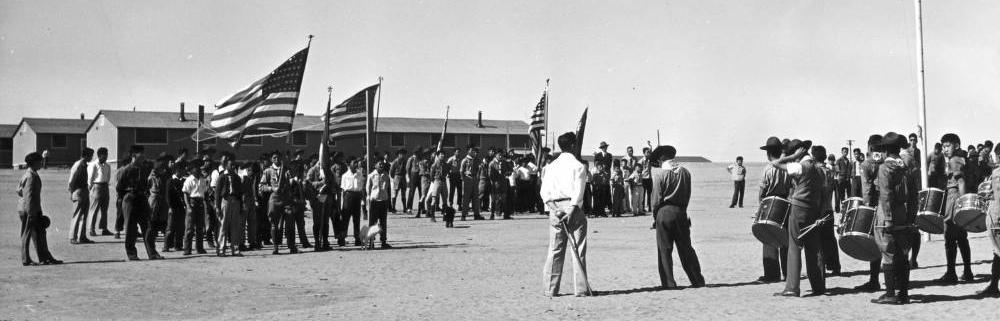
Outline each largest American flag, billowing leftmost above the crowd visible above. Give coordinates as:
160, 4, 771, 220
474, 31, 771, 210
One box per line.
210, 48, 309, 147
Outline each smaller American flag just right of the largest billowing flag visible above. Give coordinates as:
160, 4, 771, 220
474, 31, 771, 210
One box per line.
330, 84, 379, 139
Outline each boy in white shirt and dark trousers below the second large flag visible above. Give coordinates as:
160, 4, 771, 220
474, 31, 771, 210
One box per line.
335, 160, 367, 246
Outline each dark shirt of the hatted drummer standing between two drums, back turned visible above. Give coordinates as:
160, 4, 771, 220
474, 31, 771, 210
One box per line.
876, 157, 916, 226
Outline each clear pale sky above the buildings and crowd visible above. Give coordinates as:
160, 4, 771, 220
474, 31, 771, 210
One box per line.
0, 0, 1000, 161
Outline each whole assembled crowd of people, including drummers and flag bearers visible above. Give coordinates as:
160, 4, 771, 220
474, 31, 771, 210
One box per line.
17, 127, 1000, 304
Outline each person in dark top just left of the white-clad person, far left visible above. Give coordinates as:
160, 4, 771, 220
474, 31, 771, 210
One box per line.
69, 148, 94, 244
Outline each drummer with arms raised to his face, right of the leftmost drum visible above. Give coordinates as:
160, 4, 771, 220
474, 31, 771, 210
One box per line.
771, 139, 826, 297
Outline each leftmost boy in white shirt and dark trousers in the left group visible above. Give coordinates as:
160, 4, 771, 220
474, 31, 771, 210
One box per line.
181, 159, 208, 256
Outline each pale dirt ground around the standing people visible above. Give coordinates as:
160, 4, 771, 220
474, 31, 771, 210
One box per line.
0, 164, 1000, 320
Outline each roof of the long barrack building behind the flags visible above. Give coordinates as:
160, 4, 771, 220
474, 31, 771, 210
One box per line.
94, 110, 528, 134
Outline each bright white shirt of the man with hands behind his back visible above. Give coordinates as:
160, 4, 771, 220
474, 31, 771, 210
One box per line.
540, 153, 587, 206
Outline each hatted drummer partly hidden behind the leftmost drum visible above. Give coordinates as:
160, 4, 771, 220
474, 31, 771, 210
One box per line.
757, 137, 792, 283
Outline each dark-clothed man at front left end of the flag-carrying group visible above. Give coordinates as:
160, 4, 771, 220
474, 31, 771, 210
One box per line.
115, 145, 163, 261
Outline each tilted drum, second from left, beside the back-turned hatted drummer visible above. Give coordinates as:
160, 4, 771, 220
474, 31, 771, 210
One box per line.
838, 206, 882, 262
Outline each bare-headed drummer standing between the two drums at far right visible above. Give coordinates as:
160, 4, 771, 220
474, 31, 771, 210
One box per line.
938, 133, 974, 283
